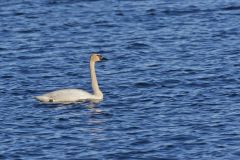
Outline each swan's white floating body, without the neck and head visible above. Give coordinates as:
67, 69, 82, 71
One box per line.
36, 89, 94, 102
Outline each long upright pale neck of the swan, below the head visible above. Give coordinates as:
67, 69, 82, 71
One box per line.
90, 61, 103, 99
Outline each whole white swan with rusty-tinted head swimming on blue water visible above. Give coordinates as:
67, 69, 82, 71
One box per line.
35, 53, 105, 103
